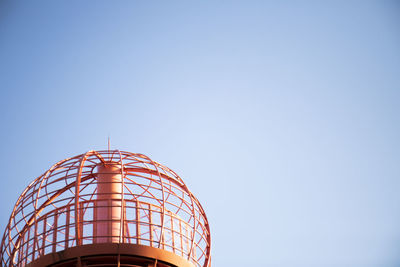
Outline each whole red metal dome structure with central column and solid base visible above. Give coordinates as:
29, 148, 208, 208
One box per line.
0, 150, 211, 267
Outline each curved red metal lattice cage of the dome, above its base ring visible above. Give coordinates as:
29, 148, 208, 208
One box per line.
0, 150, 211, 267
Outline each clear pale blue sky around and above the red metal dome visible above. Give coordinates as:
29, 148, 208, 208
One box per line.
0, 0, 400, 267
